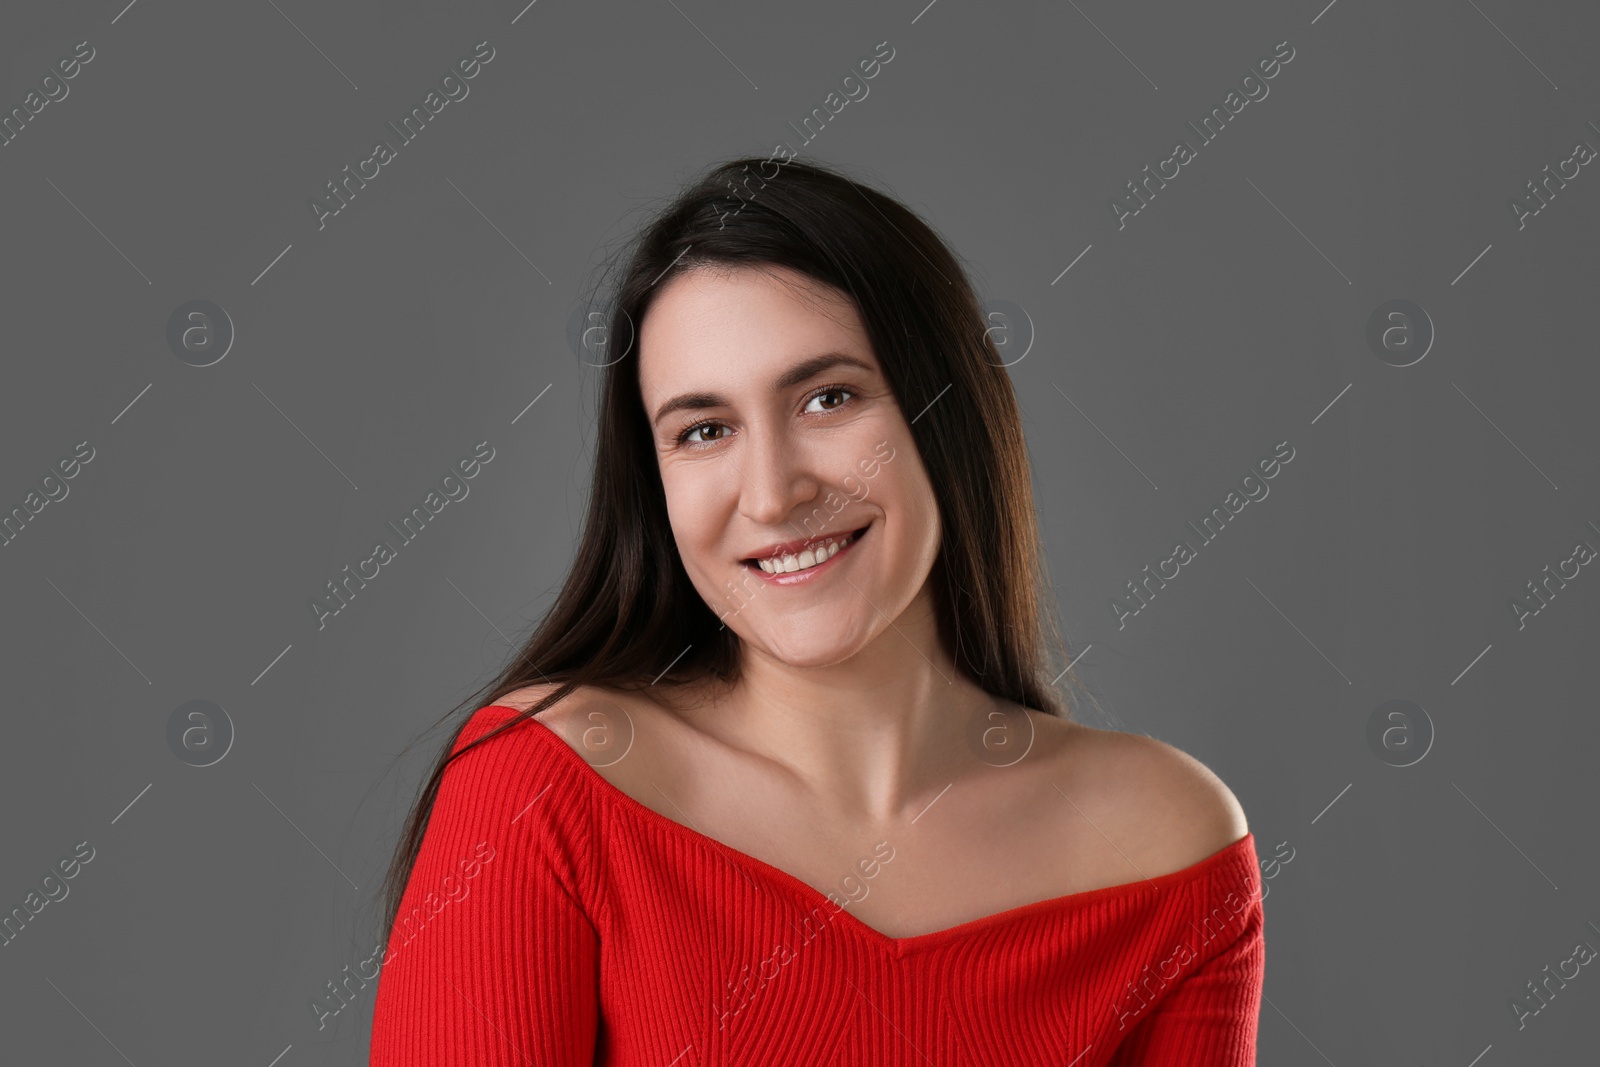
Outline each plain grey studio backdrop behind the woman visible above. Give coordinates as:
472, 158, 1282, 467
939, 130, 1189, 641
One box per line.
0, 0, 1600, 1067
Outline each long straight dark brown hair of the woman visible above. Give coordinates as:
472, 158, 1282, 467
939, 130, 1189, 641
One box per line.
378, 157, 1093, 937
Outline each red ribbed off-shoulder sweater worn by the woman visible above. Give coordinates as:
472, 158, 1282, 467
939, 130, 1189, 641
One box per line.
368, 705, 1266, 1067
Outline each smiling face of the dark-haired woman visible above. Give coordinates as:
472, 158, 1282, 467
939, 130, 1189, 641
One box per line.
640, 267, 939, 667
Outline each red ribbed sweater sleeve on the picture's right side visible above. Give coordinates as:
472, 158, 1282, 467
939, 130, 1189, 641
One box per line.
1107, 854, 1266, 1067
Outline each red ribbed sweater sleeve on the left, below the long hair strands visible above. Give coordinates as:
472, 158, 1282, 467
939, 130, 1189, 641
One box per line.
368, 709, 600, 1067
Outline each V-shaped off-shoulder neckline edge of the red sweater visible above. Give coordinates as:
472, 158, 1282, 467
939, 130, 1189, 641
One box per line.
483, 704, 1254, 955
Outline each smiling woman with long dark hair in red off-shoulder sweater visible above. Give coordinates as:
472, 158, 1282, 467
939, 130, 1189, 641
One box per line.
370, 158, 1264, 1067
